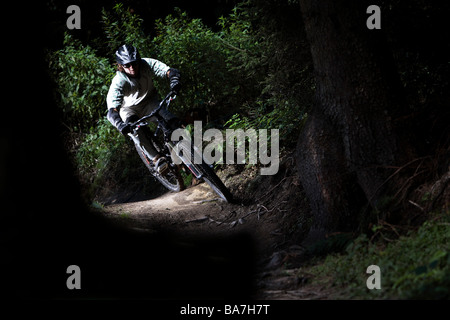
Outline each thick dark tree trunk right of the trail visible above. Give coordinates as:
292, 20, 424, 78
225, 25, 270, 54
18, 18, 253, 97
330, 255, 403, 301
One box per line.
297, 0, 416, 238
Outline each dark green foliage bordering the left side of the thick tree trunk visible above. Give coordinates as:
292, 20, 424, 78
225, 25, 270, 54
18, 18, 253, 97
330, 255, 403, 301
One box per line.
219, 0, 314, 147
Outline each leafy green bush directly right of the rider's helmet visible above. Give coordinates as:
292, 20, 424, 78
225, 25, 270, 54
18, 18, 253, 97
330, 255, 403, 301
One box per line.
153, 9, 250, 109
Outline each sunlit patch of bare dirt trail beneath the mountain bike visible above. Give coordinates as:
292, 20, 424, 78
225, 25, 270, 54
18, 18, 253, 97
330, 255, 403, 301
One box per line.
104, 183, 284, 250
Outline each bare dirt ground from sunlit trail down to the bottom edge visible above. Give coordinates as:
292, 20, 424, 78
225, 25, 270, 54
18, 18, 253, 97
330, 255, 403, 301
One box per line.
103, 151, 336, 300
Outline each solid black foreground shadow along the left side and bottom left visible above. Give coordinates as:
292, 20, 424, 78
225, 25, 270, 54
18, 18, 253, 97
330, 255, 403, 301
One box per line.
0, 1, 254, 300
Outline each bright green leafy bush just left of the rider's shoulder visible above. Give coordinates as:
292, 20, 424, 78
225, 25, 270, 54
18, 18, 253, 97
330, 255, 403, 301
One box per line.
48, 33, 114, 131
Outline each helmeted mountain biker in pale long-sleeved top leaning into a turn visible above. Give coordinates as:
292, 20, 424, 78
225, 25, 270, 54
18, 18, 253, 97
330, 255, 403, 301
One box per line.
106, 44, 181, 173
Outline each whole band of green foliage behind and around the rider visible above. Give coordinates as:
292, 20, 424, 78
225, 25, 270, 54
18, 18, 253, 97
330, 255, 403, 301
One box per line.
48, 3, 311, 201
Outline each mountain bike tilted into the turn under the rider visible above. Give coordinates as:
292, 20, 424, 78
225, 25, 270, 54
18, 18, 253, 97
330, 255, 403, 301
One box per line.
128, 92, 233, 202
